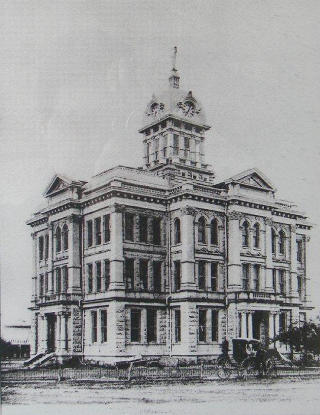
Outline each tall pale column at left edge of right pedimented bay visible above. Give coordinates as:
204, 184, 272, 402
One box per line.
228, 212, 241, 290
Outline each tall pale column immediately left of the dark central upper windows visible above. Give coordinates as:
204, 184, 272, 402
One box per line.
109, 204, 125, 291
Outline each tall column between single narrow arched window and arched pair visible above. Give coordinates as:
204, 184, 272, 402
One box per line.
181, 206, 195, 290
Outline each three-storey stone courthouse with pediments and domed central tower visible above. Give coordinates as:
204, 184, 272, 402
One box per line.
27, 52, 310, 361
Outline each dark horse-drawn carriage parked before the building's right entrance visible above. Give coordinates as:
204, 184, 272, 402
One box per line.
217, 338, 278, 379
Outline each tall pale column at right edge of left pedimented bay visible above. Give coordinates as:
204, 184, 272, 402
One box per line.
68, 215, 81, 294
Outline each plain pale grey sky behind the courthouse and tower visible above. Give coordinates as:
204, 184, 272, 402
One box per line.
0, 0, 320, 324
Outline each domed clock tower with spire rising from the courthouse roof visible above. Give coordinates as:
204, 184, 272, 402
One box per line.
139, 47, 214, 183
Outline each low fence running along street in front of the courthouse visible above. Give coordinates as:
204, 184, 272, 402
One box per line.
1, 365, 320, 382
